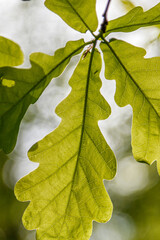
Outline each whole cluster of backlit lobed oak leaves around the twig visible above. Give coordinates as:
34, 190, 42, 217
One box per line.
0, 0, 160, 240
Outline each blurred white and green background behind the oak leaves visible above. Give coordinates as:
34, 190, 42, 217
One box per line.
0, 0, 160, 240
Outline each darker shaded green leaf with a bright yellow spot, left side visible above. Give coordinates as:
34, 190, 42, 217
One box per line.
0, 40, 86, 153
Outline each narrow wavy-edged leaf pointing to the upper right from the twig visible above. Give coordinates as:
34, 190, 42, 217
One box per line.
105, 3, 160, 36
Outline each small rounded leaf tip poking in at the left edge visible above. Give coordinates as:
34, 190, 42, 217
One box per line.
0, 36, 23, 67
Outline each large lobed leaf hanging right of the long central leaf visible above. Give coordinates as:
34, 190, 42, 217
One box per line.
101, 40, 160, 174
